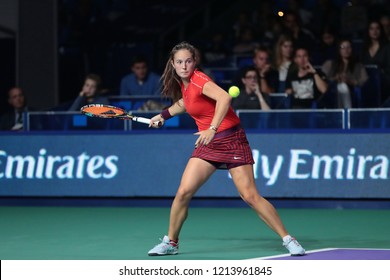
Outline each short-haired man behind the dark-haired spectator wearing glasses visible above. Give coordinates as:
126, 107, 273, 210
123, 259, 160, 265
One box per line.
253, 47, 279, 95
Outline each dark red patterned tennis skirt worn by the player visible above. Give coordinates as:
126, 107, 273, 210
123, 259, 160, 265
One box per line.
191, 126, 255, 169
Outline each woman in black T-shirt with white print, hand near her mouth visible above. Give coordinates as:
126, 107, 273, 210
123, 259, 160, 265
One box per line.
286, 47, 328, 109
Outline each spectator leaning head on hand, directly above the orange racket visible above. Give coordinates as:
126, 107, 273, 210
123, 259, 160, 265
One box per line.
68, 74, 109, 111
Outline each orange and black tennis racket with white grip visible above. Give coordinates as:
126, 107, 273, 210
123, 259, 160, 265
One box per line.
81, 104, 162, 127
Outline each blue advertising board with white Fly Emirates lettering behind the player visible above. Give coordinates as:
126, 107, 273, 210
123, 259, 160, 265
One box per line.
0, 132, 390, 199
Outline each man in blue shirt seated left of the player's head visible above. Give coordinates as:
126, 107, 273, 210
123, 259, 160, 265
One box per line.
119, 55, 161, 96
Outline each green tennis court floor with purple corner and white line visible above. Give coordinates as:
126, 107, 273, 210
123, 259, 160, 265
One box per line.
0, 206, 390, 260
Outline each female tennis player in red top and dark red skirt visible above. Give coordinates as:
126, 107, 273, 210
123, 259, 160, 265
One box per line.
148, 42, 305, 256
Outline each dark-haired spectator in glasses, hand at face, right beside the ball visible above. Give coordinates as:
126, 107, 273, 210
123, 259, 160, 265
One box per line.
232, 66, 270, 111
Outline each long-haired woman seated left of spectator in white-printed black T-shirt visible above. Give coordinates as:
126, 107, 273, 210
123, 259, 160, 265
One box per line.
274, 35, 294, 92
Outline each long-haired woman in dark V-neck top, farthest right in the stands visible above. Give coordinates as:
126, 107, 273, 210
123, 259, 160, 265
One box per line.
361, 19, 390, 103
